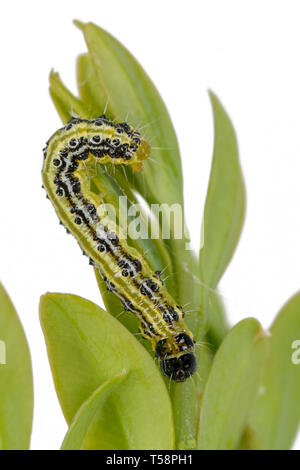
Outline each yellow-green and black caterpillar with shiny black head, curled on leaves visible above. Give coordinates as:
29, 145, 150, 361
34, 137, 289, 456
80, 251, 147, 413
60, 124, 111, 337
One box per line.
42, 115, 197, 382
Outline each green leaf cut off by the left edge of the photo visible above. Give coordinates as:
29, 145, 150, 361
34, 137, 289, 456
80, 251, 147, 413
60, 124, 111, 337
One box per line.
0, 283, 33, 450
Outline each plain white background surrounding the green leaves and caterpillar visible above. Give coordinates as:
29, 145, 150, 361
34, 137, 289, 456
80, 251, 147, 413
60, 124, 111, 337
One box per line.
0, 0, 300, 449
